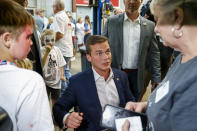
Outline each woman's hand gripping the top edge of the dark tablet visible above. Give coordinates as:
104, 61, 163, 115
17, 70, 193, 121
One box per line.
125, 102, 147, 113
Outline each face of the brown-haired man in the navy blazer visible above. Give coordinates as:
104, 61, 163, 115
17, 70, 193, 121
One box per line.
86, 41, 111, 74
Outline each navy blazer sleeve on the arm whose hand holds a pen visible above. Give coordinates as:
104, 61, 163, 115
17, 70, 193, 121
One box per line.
53, 80, 76, 128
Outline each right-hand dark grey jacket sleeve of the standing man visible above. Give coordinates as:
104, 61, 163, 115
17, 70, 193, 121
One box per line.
150, 33, 161, 82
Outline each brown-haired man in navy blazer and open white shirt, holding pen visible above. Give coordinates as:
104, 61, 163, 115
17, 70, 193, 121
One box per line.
53, 36, 135, 131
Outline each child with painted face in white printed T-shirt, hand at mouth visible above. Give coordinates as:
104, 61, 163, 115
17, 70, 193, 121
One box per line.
41, 30, 66, 105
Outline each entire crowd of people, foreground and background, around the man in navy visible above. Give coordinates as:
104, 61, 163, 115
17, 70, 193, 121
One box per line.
0, 0, 197, 131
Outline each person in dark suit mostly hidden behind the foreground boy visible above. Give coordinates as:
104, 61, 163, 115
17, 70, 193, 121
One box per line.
13, 0, 43, 76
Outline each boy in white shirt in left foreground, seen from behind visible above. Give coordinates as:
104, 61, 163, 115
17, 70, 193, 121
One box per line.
0, 0, 54, 131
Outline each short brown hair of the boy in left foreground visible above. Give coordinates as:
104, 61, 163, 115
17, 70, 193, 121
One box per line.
0, 0, 35, 37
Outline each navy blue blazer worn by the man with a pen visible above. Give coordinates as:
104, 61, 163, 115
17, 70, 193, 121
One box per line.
53, 68, 135, 131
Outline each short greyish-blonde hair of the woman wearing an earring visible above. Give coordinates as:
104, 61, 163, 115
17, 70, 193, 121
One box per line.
150, 0, 197, 25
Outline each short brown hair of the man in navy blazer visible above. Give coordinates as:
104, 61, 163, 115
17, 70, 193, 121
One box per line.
86, 35, 108, 54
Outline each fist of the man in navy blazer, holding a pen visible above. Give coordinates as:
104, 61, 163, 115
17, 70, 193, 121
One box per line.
65, 112, 83, 128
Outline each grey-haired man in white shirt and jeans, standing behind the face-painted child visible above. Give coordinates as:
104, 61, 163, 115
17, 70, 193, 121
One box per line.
51, 0, 73, 94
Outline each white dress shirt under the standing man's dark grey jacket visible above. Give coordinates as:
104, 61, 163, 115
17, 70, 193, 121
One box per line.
122, 13, 140, 69
